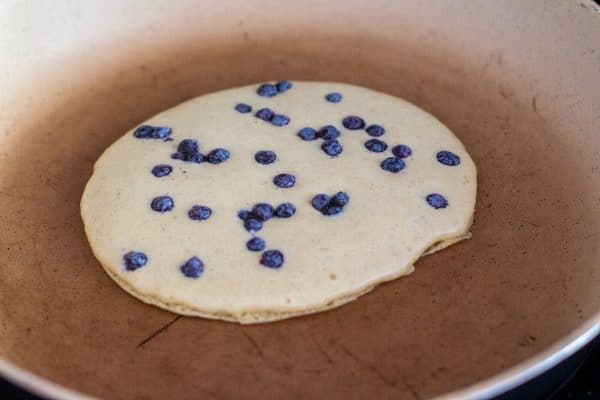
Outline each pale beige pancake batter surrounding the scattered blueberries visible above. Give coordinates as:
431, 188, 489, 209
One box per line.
81, 81, 476, 323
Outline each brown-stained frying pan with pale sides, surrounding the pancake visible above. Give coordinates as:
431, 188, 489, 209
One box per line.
0, 0, 600, 399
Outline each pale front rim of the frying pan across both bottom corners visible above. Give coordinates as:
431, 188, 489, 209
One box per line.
0, 312, 600, 400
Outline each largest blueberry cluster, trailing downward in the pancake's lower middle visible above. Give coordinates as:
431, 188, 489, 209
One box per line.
238, 203, 296, 268
